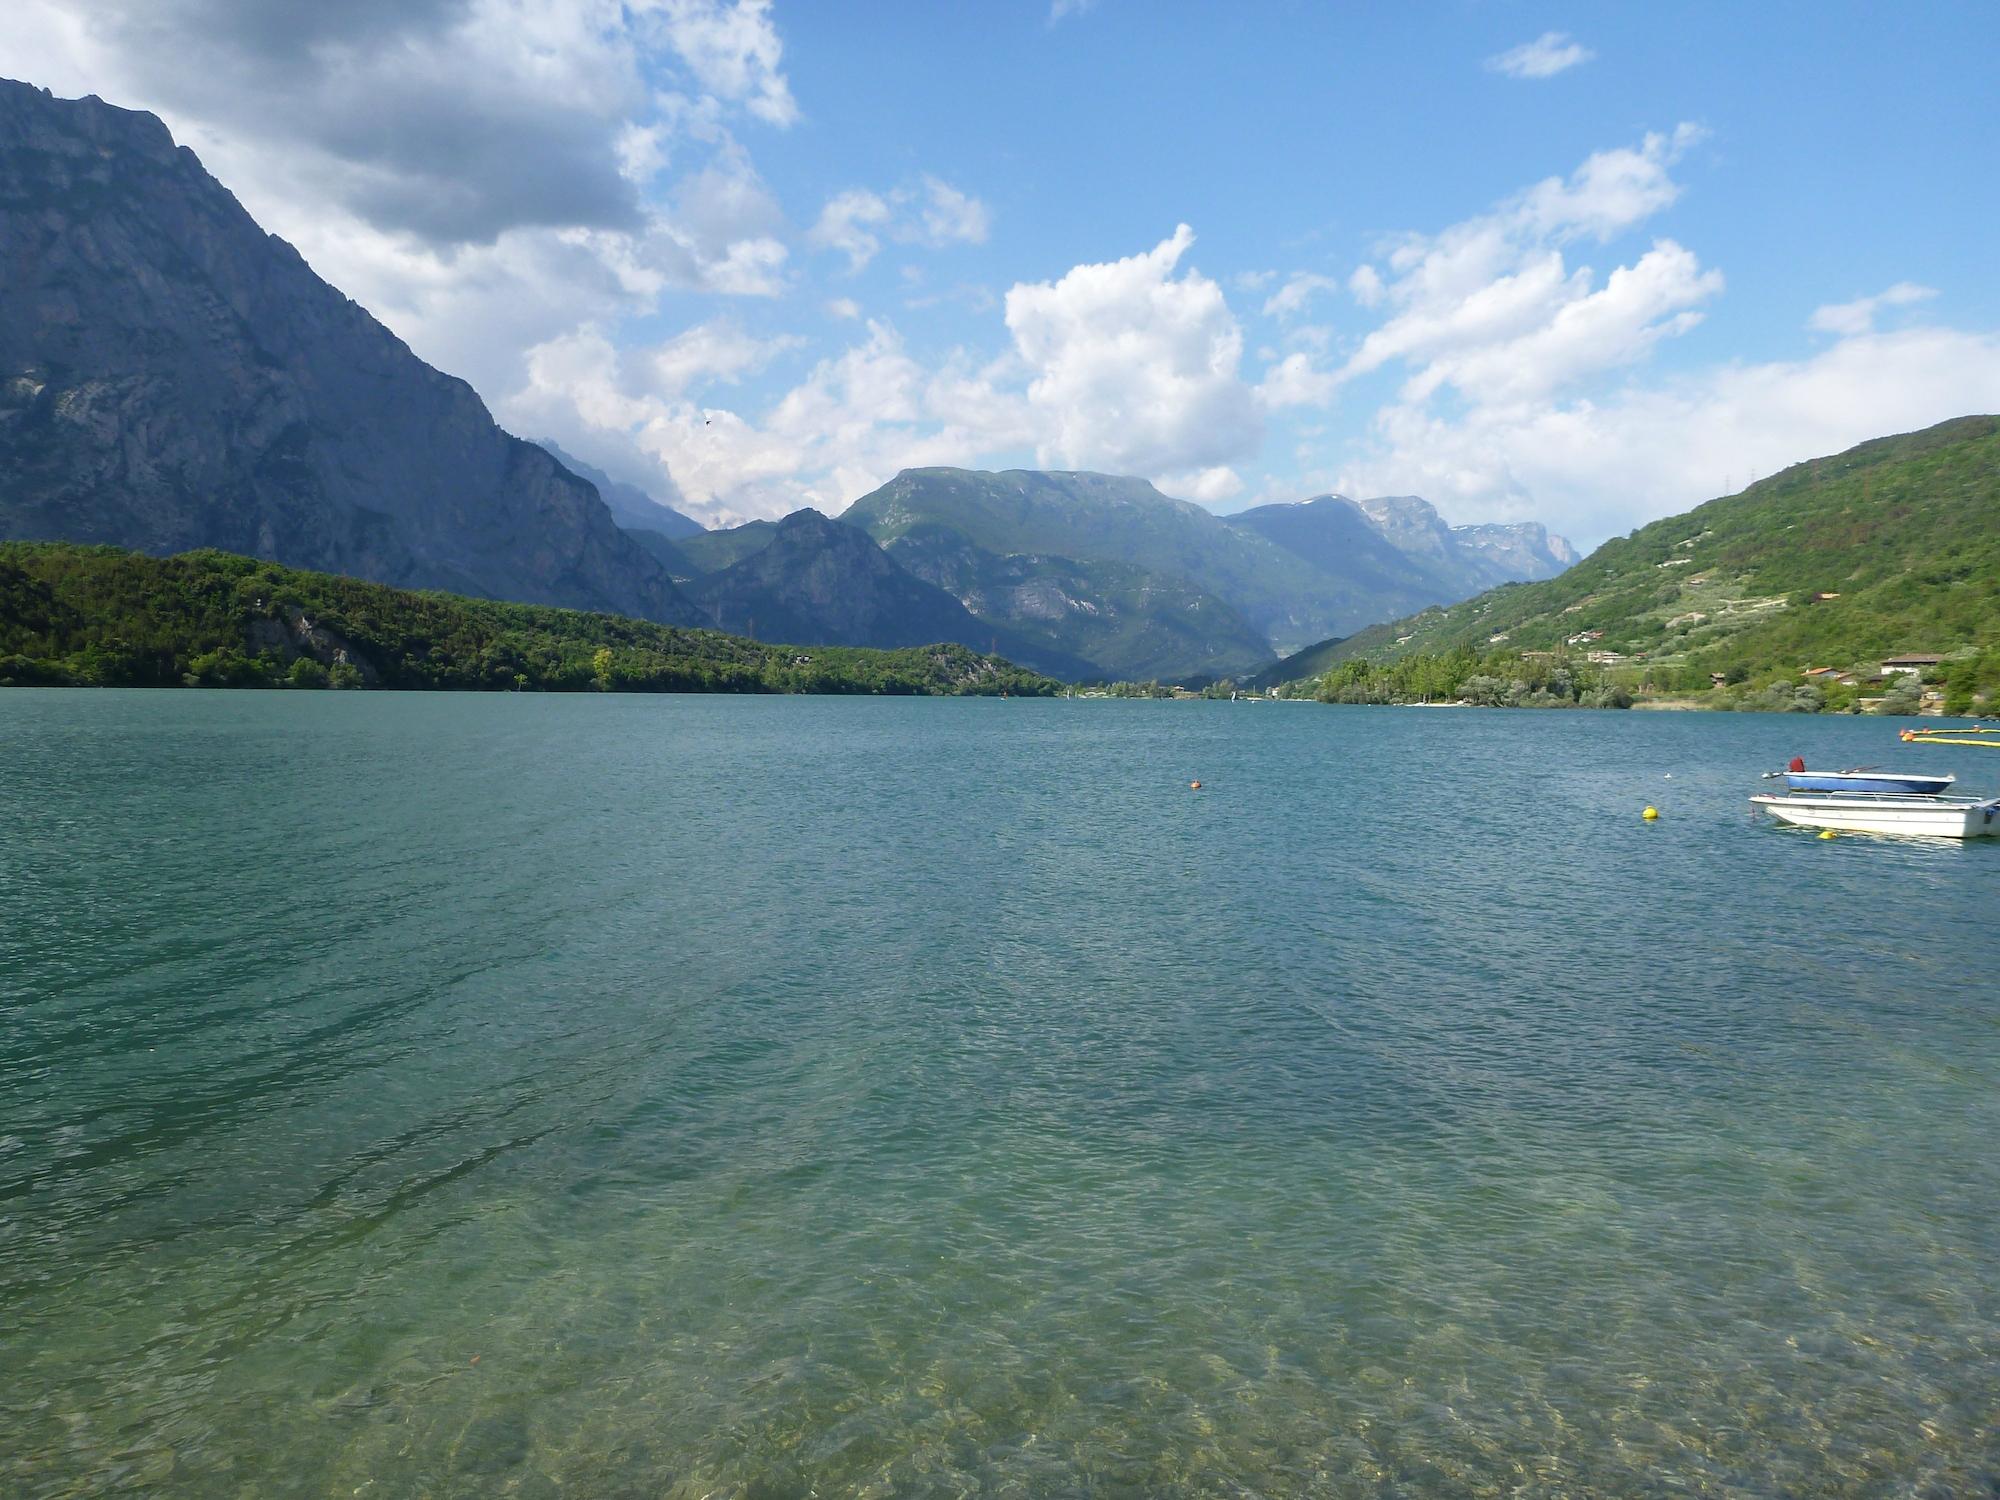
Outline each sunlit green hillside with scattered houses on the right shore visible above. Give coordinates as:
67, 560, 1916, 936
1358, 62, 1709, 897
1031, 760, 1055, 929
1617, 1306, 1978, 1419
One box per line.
1326, 416, 2000, 692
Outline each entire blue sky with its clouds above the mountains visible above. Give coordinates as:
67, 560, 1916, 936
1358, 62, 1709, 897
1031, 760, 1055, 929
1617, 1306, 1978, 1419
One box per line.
0, 0, 2000, 544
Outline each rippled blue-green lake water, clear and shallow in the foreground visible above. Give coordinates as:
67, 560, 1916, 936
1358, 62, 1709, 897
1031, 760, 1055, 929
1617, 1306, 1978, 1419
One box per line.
0, 690, 2000, 1496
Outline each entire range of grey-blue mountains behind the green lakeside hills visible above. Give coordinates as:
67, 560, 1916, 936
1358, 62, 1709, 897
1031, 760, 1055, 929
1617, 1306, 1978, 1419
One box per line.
0, 82, 1574, 680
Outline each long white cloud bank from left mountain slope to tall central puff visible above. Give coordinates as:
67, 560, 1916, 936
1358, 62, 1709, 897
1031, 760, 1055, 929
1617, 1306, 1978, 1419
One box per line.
502, 226, 1264, 522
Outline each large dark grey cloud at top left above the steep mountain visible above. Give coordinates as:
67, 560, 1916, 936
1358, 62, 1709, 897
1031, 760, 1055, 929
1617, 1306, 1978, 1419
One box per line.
0, 0, 790, 244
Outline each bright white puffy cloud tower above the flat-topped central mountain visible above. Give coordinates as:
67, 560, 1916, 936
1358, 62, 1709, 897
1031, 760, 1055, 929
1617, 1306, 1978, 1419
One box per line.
1006, 224, 1262, 476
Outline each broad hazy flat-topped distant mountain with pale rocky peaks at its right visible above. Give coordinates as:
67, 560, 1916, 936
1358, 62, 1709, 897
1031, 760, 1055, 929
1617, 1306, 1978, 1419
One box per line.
842, 468, 1568, 680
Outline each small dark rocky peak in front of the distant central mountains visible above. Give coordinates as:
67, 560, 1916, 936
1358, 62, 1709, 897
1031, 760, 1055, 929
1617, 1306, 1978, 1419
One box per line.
688, 510, 1090, 678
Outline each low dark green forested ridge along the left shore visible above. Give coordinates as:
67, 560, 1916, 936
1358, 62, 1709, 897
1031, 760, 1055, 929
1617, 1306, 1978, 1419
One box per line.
0, 542, 1058, 694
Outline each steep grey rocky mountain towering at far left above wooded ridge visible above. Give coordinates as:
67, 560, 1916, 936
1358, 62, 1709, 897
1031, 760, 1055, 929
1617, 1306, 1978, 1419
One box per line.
0, 80, 698, 622
